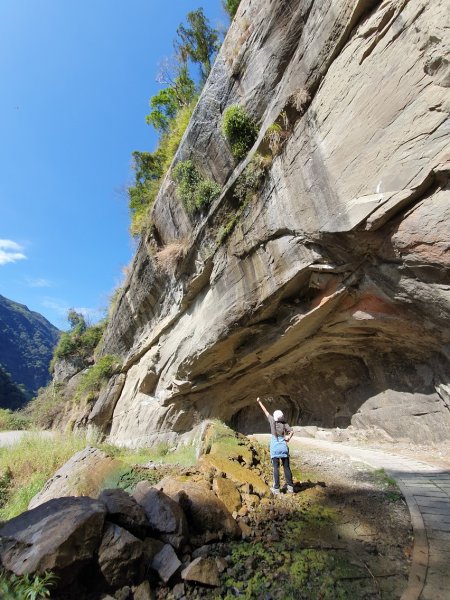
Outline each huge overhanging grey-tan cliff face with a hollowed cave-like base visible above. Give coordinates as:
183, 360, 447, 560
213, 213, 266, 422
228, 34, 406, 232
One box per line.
93, 0, 450, 446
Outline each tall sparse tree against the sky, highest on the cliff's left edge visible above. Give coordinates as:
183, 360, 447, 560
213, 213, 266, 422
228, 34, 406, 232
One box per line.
175, 8, 220, 84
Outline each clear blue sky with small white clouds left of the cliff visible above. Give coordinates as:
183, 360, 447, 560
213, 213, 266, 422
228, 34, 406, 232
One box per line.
0, 0, 227, 329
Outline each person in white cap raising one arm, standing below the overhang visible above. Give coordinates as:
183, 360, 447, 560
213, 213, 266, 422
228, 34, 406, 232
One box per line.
256, 398, 294, 494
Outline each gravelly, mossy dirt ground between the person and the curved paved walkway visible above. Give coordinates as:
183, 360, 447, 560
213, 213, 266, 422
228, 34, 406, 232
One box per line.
222, 435, 413, 600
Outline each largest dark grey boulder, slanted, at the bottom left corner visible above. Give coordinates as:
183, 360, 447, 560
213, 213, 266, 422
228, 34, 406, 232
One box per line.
0, 497, 106, 583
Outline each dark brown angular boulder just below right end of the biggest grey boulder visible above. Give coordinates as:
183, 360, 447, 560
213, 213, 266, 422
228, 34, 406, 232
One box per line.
98, 523, 143, 588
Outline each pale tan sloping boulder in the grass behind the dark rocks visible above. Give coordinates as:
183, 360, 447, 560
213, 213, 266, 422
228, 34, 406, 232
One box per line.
28, 446, 120, 509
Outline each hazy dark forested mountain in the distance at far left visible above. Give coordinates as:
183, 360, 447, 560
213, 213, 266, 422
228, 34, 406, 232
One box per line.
0, 295, 60, 408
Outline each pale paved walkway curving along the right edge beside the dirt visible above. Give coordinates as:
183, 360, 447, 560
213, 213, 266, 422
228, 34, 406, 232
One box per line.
290, 436, 450, 600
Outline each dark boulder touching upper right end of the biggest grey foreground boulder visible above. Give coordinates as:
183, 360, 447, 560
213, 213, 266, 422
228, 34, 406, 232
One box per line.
98, 489, 149, 539
